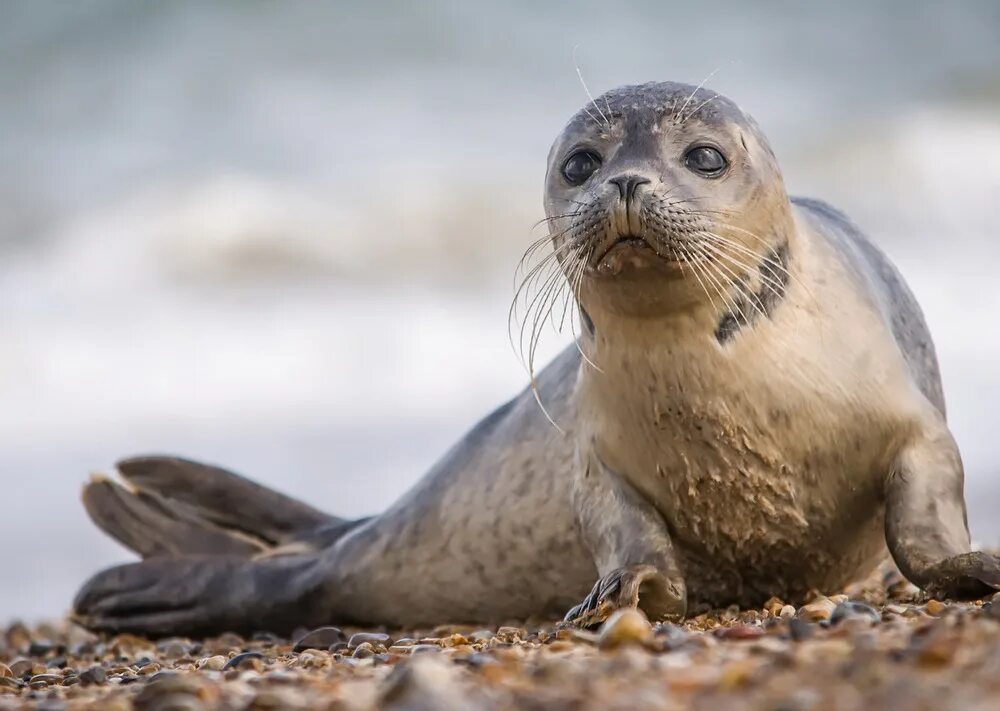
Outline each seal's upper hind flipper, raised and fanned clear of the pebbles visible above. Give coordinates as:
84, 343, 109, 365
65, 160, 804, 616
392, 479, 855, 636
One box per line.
83, 457, 340, 558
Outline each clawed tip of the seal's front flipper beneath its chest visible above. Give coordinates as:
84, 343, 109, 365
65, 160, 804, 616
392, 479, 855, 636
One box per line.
563, 565, 687, 628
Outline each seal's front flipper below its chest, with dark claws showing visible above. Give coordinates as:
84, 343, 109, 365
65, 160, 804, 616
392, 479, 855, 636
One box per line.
565, 455, 687, 627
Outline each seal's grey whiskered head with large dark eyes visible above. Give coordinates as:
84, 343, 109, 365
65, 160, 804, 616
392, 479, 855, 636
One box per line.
545, 82, 791, 320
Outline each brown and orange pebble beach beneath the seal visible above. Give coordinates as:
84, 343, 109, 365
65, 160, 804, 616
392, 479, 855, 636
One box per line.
0, 560, 1000, 711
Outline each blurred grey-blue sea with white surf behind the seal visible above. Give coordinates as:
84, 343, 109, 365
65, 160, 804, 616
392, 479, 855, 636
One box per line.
0, 0, 1000, 623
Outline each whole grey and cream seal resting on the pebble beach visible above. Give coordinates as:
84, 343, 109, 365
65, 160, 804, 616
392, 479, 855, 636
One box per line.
75, 82, 1000, 636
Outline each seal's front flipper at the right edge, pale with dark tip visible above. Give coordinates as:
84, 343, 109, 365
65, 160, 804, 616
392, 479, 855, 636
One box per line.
885, 427, 1000, 599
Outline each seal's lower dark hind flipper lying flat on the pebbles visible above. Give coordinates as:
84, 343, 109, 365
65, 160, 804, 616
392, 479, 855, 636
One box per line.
73, 556, 332, 637
